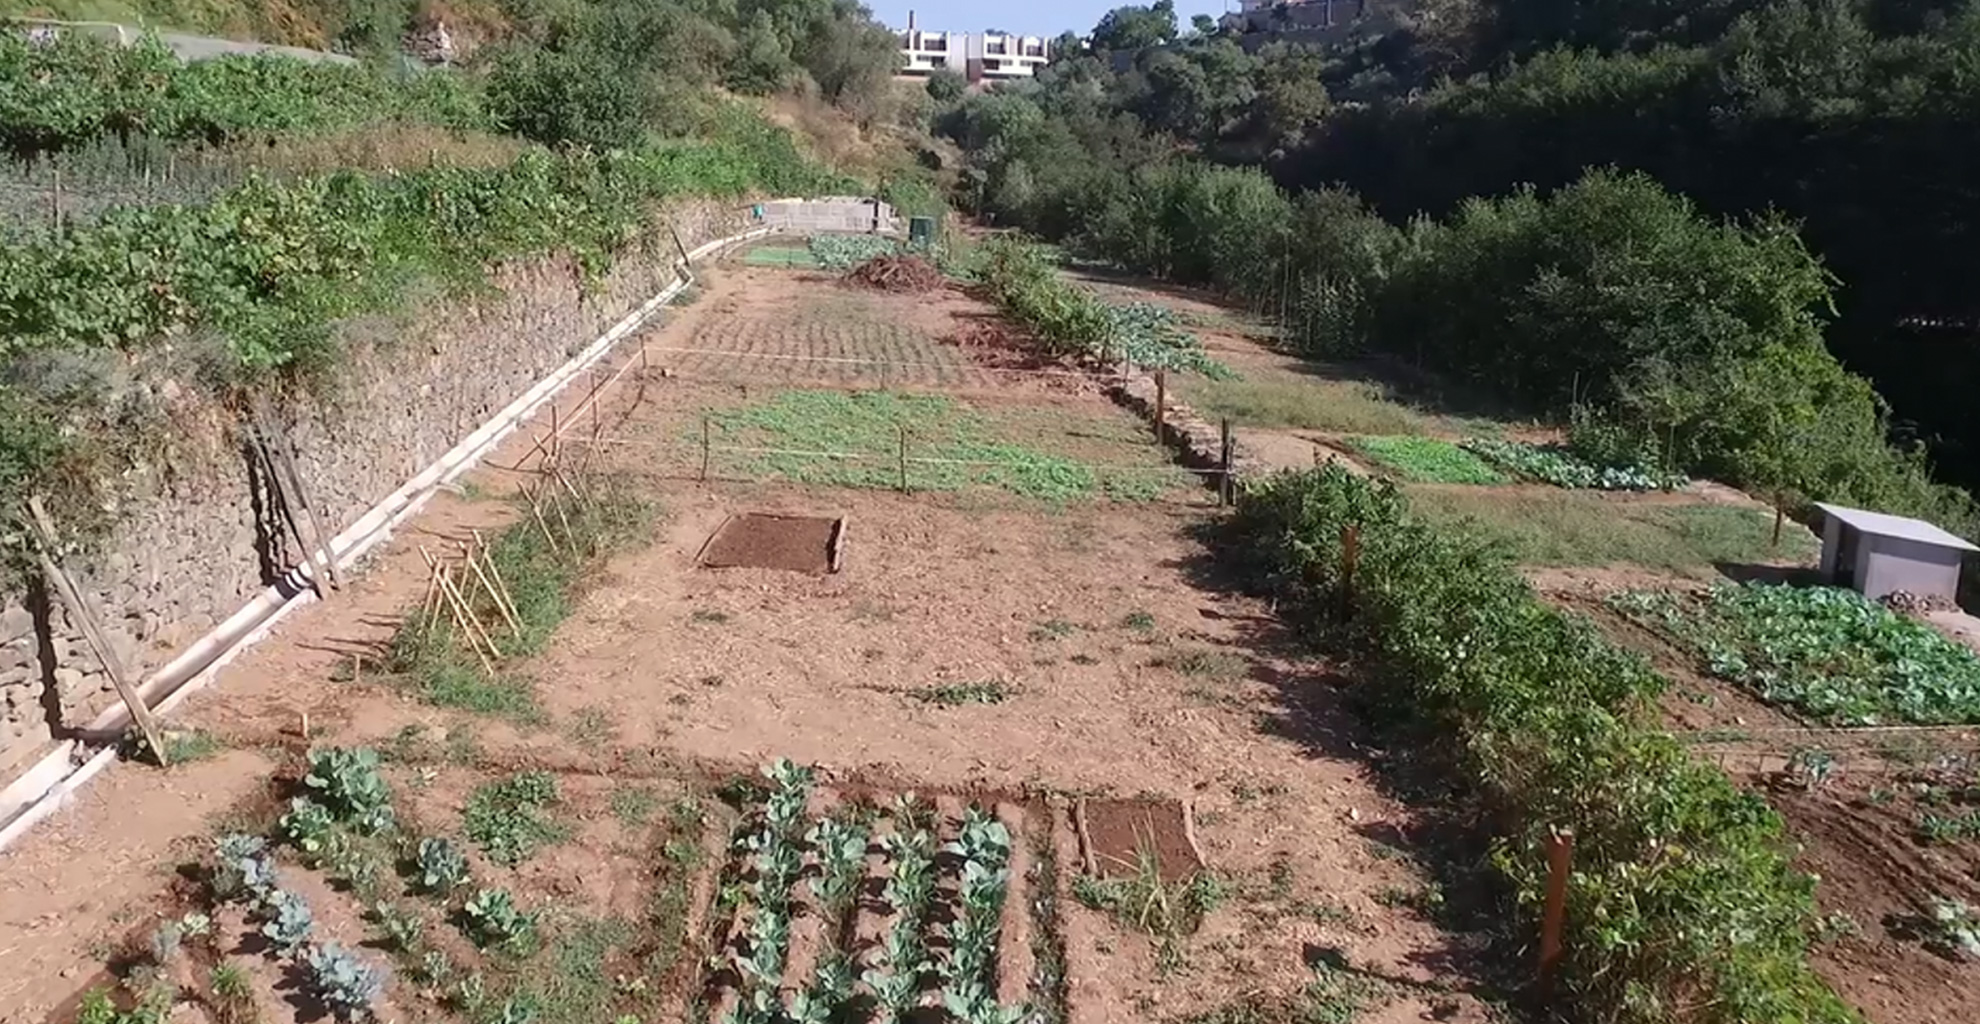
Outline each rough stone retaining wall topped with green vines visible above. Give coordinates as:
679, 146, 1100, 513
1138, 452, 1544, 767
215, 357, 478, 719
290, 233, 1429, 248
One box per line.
0, 202, 748, 772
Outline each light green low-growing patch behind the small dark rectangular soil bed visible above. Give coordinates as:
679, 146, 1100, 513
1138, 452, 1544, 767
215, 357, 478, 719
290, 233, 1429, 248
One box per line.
697, 390, 1180, 501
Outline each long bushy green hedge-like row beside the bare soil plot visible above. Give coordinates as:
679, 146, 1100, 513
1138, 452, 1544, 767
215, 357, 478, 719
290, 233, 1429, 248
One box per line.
1226, 465, 1859, 1024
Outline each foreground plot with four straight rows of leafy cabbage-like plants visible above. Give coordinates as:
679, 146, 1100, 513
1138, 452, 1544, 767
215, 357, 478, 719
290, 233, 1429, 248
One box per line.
701, 761, 1049, 1024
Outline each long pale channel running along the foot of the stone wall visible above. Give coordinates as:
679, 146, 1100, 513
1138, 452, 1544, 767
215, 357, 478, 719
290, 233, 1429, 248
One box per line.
0, 228, 772, 850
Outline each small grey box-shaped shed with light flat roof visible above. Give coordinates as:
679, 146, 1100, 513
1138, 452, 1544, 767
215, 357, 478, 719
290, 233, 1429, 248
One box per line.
1816, 501, 1980, 600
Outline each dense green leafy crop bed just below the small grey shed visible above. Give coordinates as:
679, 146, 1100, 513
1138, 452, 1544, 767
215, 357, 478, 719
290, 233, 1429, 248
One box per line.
1610, 584, 1980, 725
